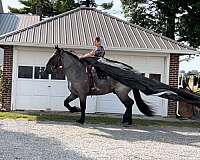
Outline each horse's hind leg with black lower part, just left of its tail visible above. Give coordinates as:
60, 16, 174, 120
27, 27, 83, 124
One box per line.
116, 91, 134, 125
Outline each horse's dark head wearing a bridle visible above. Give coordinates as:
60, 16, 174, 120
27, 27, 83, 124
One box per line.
44, 46, 64, 74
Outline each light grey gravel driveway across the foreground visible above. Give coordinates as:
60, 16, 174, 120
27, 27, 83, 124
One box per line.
0, 120, 200, 160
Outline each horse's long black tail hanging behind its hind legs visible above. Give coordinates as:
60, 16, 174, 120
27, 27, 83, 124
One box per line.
133, 89, 154, 116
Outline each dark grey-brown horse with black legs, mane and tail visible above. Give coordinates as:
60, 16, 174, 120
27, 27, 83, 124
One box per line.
45, 47, 153, 125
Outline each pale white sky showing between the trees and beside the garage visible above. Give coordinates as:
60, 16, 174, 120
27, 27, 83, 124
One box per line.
2, 0, 200, 72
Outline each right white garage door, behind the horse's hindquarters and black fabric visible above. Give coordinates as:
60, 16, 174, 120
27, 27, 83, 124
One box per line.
97, 55, 167, 116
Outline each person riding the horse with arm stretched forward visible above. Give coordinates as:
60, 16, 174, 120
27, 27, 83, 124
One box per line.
80, 37, 105, 90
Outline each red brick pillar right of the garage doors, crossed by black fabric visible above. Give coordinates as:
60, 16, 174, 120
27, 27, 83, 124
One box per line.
168, 54, 179, 116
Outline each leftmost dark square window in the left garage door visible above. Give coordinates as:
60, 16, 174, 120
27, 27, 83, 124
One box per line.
18, 66, 33, 79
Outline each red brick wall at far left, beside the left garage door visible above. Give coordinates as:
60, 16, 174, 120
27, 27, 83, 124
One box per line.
0, 46, 13, 111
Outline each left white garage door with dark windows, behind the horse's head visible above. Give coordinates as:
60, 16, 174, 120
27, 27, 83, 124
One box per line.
14, 50, 96, 112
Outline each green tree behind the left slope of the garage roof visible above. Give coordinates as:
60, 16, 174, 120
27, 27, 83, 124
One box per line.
8, 0, 113, 18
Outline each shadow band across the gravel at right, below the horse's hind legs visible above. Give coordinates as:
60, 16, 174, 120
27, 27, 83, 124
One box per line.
88, 126, 200, 148
